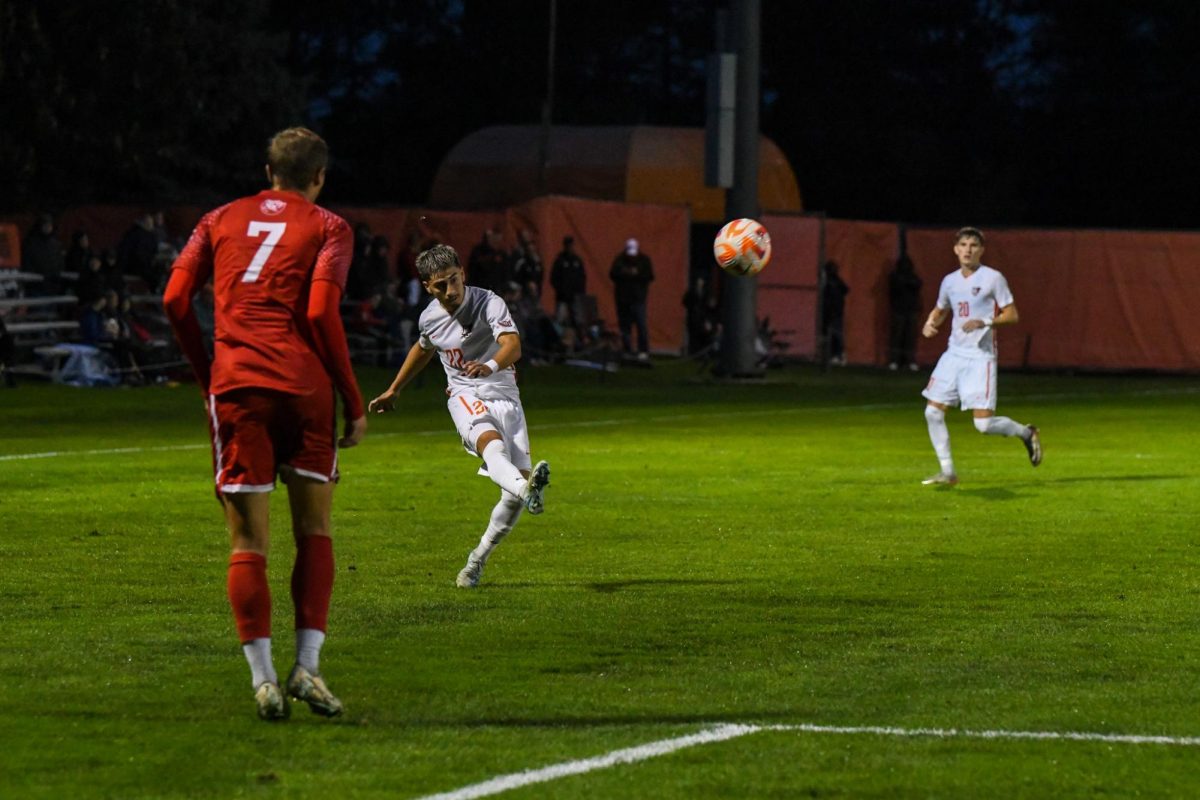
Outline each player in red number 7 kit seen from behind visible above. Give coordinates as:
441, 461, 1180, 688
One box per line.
163, 127, 367, 720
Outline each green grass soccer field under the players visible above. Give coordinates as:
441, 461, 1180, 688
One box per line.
0, 362, 1200, 799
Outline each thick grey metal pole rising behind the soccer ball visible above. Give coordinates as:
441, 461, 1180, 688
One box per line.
718, 0, 763, 378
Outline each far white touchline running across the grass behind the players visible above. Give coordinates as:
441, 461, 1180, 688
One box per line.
0, 387, 1200, 462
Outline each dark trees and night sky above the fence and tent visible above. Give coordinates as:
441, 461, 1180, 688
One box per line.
7, 0, 1200, 227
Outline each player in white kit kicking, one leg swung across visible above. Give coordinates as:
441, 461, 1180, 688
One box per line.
368, 245, 550, 589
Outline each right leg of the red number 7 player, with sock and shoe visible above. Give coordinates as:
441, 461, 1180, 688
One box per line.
287, 474, 343, 717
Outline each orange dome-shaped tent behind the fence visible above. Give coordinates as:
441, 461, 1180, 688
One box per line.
430, 125, 802, 222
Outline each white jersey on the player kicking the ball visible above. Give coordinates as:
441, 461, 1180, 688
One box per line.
418, 287, 521, 401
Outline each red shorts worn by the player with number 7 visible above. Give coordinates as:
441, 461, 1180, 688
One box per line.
209, 387, 337, 493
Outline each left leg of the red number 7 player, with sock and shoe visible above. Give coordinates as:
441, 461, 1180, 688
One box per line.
222, 492, 289, 721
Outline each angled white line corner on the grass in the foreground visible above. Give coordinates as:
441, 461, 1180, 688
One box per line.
418, 724, 1200, 800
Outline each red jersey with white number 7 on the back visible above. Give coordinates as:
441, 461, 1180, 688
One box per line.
173, 190, 356, 397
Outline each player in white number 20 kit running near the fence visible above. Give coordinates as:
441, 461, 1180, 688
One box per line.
922, 228, 1042, 486
